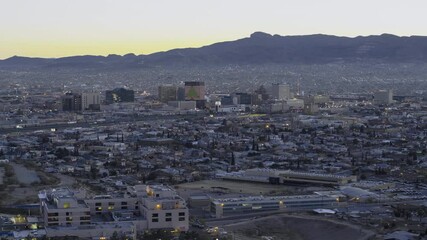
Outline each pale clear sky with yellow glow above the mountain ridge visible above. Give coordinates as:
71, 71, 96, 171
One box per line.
0, 0, 427, 59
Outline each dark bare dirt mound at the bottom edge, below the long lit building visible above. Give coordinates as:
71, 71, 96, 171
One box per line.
224, 215, 374, 240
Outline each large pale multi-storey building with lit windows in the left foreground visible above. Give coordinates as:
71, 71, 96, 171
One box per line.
38, 185, 189, 238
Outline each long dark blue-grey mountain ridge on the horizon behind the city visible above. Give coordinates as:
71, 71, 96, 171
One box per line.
0, 32, 427, 70
